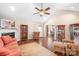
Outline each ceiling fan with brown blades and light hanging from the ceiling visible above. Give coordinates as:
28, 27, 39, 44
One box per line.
33, 3, 50, 16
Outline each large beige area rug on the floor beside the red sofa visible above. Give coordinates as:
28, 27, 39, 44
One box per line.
19, 42, 56, 56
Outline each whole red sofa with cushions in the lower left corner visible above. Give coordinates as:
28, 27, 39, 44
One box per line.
0, 36, 21, 56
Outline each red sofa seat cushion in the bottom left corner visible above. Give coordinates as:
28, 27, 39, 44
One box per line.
0, 47, 21, 56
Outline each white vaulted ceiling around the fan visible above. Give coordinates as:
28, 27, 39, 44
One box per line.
0, 3, 79, 23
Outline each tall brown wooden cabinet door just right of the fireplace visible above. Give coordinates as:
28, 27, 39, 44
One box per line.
20, 25, 28, 40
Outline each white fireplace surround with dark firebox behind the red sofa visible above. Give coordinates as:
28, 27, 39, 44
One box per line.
0, 29, 20, 41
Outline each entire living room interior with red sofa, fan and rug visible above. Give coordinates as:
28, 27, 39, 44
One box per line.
0, 3, 79, 56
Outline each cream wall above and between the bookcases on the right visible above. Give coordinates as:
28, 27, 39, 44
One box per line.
45, 11, 79, 39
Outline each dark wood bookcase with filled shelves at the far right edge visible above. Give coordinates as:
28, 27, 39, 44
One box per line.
69, 23, 79, 40
